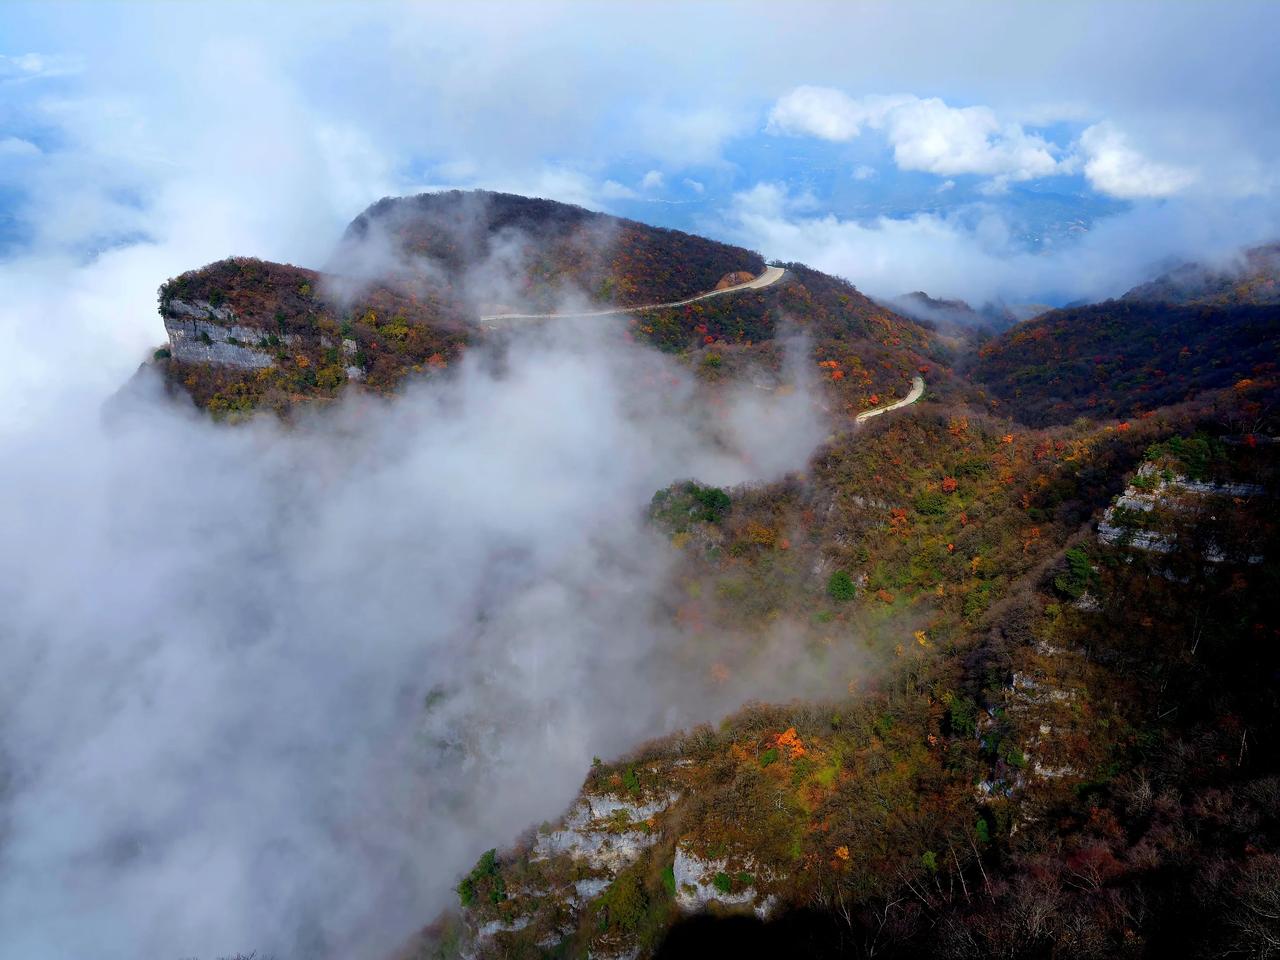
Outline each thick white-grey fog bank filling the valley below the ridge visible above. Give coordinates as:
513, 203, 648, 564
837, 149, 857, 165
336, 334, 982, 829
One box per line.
0, 323, 823, 960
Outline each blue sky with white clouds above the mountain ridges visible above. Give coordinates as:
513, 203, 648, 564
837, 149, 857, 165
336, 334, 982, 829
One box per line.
0, 1, 1280, 407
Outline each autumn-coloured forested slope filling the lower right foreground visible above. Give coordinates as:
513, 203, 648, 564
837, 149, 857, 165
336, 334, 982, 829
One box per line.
432, 363, 1280, 957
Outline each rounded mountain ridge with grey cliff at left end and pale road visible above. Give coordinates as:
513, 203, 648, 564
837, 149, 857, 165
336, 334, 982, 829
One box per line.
147, 192, 945, 417
